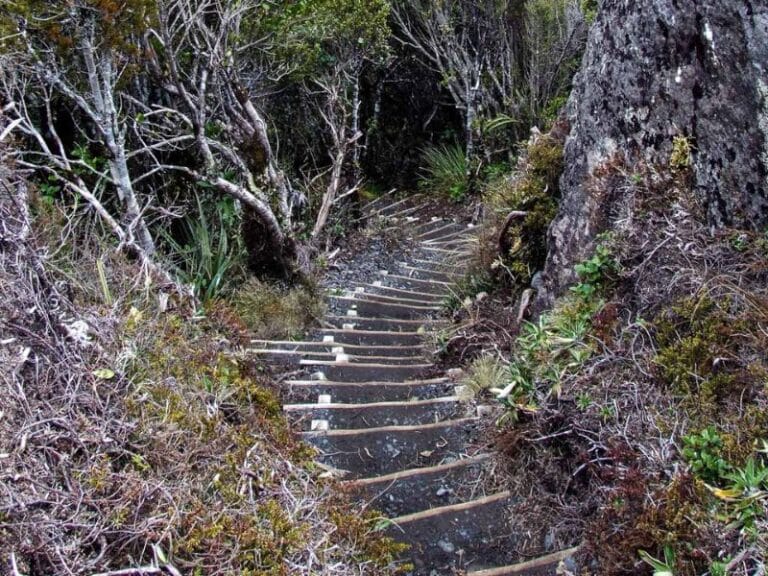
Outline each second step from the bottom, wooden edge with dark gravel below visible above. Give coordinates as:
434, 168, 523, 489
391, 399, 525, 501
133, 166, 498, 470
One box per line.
387, 492, 516, 576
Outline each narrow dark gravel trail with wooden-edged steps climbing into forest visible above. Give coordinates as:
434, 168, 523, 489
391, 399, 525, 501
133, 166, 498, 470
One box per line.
248, 198, 573, 576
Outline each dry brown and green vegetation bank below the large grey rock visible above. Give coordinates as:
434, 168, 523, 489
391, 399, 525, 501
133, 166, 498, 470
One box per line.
450, 138, 768, 576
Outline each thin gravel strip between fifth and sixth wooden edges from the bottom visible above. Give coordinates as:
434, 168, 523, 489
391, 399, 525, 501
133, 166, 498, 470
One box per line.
285, 382, 454, 404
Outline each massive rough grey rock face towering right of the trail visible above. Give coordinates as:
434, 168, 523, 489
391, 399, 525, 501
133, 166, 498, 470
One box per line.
540, 0, 768, 304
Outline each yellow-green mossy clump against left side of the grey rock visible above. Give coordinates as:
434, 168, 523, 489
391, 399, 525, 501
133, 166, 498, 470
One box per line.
485, 135, 563, 286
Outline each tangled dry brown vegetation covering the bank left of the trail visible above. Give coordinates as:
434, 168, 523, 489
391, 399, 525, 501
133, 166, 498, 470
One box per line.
0, 163, 404, 576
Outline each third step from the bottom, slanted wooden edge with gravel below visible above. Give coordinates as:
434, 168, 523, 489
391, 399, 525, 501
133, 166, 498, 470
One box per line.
343, 454, 489, 518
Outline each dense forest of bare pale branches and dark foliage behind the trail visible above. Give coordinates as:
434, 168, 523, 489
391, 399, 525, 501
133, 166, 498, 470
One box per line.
0, 0, 586, 290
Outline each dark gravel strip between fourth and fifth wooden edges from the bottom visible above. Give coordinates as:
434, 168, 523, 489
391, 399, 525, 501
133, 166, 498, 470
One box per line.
288, 400, 462, 432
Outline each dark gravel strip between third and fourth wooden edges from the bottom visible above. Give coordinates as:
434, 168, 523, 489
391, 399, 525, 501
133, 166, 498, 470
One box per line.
304, 424, 477, 479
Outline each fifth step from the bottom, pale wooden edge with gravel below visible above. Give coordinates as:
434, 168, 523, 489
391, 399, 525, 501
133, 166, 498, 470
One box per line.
283, 396, 465, 430
